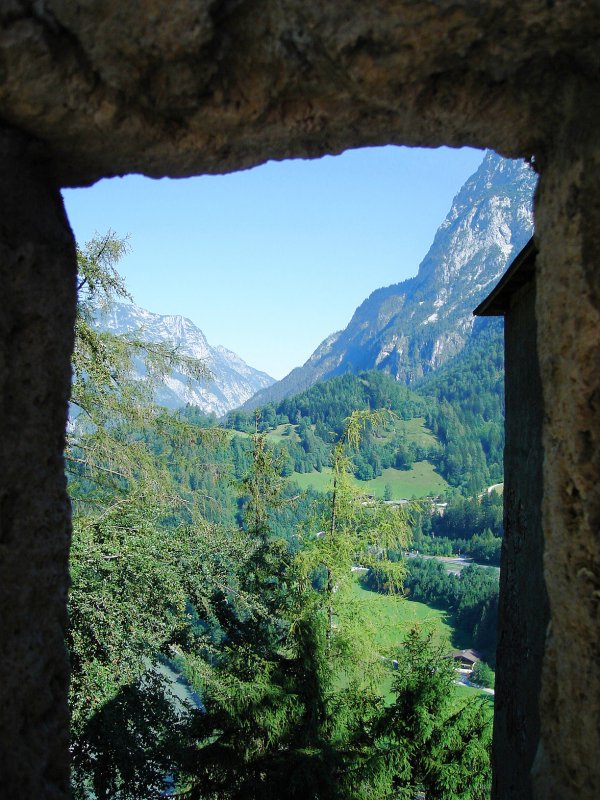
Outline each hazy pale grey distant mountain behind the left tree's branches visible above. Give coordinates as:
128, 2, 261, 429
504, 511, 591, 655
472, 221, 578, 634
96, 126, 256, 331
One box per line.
98, 303, 274, 416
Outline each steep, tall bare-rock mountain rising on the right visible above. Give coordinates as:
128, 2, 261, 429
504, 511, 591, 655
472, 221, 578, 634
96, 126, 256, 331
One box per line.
244, 152, 536, 409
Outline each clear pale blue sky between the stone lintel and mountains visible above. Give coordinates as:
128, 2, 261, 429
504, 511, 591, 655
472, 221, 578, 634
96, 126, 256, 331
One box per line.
63, 147, 483, 378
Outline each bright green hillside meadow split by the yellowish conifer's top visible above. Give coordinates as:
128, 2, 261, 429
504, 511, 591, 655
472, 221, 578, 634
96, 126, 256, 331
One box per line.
290, 461, 448, 500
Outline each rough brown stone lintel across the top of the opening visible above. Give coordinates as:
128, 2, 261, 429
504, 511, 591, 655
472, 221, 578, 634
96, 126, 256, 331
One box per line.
0, 0, 598, 185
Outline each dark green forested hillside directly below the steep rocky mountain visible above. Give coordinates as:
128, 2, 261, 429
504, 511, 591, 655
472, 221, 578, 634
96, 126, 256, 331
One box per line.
225, 320, 504, 499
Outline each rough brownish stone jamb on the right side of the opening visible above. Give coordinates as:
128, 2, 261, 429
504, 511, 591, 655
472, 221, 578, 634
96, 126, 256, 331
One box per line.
535, 103, 600, 800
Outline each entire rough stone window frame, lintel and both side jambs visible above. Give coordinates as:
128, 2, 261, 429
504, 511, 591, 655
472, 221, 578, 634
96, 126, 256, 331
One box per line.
0, 0, 600, 800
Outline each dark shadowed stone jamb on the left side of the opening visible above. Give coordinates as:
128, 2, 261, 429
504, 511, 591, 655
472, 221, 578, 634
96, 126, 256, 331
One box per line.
0, 132, 75, 800
